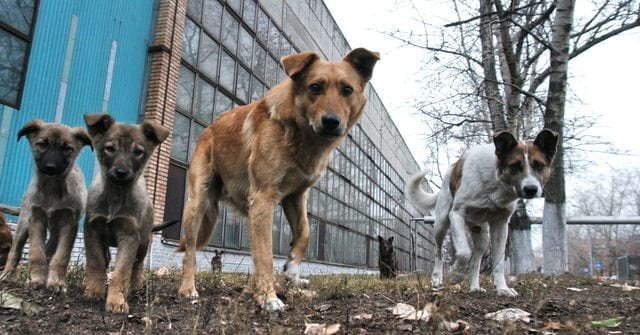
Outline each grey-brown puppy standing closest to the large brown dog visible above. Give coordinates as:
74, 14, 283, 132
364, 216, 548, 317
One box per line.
84, 114, 169, 313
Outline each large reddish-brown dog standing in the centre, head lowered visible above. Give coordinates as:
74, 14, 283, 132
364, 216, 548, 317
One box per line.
179, 48, 379, 310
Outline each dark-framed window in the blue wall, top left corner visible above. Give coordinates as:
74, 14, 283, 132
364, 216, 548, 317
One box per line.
0, 0, 37, 108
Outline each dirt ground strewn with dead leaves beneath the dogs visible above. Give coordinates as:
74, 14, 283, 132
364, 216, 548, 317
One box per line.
0, 268, 640, 334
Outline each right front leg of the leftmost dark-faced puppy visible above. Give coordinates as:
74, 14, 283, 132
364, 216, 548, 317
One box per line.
47, 210, 78, 292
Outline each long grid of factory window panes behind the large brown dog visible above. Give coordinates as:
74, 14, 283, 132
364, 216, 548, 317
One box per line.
165, 0, 427, 269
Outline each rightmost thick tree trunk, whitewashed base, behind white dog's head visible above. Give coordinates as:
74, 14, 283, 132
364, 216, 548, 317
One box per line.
542, 0, 575, 275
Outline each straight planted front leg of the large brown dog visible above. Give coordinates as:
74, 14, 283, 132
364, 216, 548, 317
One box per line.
249, 191, 285, 311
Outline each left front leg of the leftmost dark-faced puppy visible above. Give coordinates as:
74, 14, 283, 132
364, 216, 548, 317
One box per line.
27, 208, 47, 286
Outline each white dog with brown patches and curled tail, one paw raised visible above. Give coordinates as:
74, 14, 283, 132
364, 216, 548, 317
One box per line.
406, 129, 558, 296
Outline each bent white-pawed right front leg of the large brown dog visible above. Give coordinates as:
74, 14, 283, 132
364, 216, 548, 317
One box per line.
282, 191, 309, 285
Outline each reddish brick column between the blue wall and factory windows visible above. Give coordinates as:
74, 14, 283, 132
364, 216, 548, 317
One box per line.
144, 0, 188, 224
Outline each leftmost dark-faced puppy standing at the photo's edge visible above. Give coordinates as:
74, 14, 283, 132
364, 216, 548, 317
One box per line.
0, 120, 91, 291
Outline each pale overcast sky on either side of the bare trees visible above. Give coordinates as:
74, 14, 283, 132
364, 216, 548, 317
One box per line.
325, 0, 640, 184
